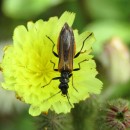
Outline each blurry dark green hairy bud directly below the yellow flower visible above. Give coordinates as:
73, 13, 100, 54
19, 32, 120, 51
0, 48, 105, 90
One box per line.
36, 110, 73, 130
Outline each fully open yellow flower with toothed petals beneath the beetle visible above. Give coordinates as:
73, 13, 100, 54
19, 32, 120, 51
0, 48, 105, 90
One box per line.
1, 12, 102, 116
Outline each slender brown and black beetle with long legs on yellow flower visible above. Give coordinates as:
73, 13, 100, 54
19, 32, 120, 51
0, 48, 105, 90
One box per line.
43, 23, 92, 104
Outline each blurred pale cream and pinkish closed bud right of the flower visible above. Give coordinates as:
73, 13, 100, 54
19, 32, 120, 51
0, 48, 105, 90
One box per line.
101, 37, 130, 83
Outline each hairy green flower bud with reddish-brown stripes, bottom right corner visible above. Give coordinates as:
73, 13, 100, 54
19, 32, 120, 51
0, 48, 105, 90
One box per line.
100, 99, 130, 130
